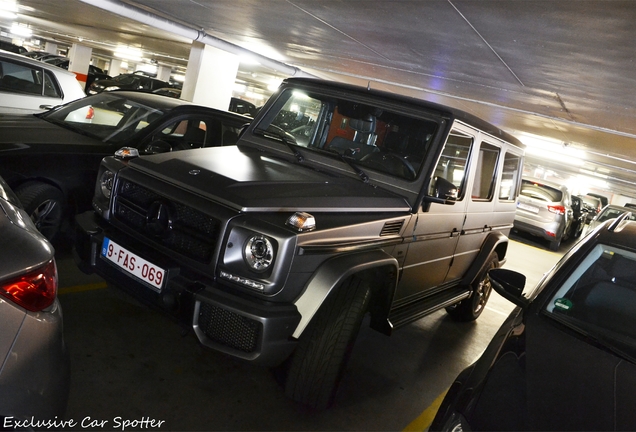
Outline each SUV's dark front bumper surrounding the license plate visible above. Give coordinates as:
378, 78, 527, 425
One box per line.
74, 211, 300, 365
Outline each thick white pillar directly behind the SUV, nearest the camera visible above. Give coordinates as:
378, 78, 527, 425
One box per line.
181, 41, 239, 110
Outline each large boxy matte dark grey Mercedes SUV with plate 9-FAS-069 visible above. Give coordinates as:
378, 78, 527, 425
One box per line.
76, 79, 523, 408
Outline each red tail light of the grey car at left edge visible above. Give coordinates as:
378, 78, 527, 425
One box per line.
0, 260, 57, 312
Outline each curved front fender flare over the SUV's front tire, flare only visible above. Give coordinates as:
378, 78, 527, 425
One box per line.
293, 250, 399, 338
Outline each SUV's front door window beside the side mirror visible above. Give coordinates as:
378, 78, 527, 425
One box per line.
429, 130, 474, 201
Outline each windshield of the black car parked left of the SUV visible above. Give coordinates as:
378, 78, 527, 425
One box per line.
41, 92, 164, 144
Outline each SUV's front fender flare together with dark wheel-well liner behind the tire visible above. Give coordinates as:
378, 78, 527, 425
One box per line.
293, 249, 399, 338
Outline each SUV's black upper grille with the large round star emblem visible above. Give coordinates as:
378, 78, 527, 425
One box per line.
114, 180, 220, 263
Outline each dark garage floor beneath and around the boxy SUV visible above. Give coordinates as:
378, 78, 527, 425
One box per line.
52, 233, 570, 431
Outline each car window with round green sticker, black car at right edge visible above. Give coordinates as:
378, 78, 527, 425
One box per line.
545, 244, 636, 358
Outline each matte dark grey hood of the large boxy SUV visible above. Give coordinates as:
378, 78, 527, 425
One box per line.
129, 146, 411, 212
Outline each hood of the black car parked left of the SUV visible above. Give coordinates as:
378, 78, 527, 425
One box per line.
0, 115, 101, 149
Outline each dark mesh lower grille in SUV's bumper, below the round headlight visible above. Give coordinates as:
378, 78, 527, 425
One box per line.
199, 303, 262, 353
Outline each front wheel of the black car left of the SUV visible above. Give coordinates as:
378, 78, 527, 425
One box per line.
15, 182, 64, 241
